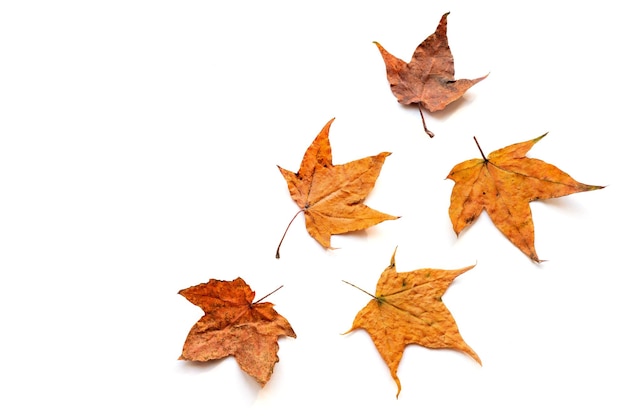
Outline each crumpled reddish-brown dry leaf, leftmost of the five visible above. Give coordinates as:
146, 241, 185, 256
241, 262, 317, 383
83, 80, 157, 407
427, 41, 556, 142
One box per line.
178, 278, 296, 386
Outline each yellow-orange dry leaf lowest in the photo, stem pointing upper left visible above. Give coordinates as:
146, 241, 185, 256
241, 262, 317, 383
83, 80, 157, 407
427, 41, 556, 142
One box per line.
346, 251, 482, 397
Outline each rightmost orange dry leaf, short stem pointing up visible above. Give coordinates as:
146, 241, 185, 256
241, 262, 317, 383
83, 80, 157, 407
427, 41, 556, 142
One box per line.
447, 134, 603, 263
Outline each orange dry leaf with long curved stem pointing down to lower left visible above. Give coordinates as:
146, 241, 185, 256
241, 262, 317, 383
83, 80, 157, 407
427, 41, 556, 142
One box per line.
276, 119, 398, 258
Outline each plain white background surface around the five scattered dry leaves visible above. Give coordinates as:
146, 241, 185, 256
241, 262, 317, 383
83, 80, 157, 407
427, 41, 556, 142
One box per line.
0, 0, 626, 417
